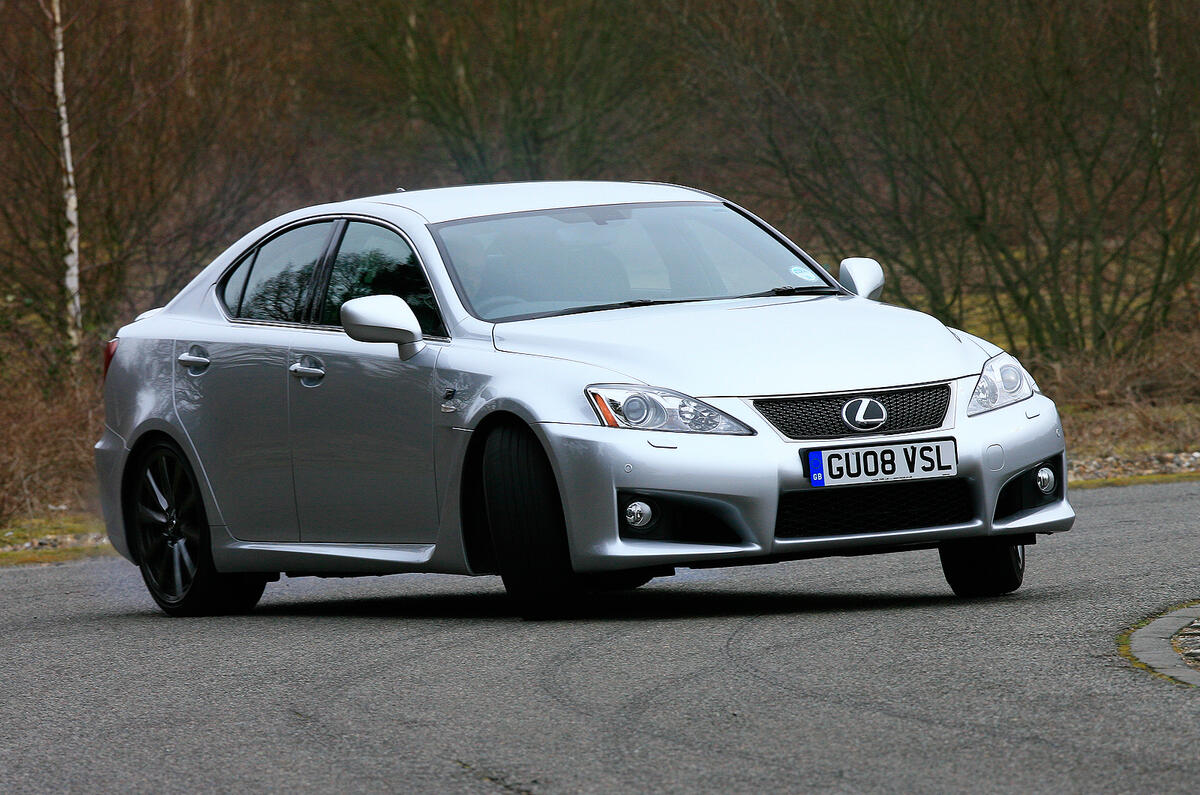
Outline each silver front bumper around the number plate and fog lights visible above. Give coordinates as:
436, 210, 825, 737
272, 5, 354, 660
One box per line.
539, 377, 1075, 572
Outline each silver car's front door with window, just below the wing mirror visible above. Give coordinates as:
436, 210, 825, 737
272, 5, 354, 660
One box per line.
288, 221, 445, 544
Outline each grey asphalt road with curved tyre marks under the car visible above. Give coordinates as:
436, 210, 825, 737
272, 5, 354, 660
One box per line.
0, 483, 1200, 793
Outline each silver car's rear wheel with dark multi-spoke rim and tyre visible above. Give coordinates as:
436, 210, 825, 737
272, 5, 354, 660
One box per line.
126, 441, 266, 616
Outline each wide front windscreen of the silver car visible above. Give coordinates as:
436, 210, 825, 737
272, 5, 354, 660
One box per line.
432, 203, 834, 322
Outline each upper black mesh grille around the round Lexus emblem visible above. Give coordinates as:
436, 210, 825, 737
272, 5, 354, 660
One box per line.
754, 384, 950, 440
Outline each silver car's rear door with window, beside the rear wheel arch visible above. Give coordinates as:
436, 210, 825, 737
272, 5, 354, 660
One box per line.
175, 221, 335, 540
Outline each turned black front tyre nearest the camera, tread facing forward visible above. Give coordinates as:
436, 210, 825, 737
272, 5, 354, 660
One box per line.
484, 425, 577, 617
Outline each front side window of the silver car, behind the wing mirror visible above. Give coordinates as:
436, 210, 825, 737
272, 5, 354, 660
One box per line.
317, 221, 446, 336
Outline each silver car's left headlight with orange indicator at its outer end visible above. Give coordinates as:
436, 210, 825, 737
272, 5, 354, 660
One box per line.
584, 384, 754, 436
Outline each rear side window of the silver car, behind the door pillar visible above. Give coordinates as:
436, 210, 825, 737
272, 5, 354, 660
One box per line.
226, 221, 334, 322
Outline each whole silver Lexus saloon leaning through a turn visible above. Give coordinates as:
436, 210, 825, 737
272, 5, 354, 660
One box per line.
96, 183, 1074, 615
